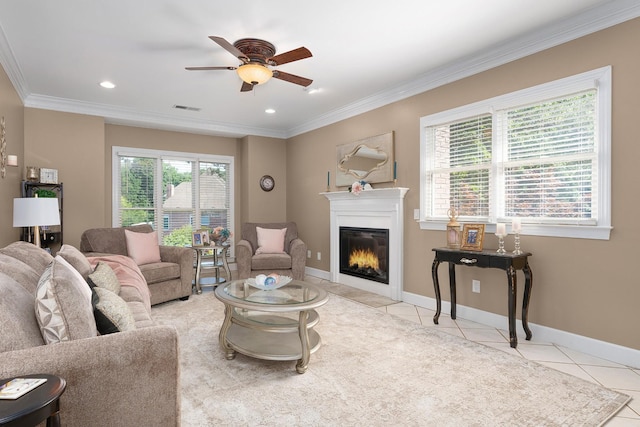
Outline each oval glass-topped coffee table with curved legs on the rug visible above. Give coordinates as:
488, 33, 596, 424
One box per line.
215, 280, 329, 374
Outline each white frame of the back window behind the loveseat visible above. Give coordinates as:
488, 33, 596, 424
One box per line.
111, 146, 235, 243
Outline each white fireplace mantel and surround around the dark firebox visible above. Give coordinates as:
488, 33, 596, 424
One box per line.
321, 187, 409, 301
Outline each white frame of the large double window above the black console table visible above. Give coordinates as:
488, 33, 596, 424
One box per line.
417, 66, 612, 240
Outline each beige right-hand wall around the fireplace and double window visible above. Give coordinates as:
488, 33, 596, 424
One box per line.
287, 19, 640, 349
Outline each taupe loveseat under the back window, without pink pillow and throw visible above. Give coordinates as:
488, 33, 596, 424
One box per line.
80, 224, 194, 305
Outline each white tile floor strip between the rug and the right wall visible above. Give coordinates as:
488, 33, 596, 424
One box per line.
305, 276, 640, 427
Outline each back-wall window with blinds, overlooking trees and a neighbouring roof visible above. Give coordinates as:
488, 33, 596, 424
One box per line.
113, 147, 233, 246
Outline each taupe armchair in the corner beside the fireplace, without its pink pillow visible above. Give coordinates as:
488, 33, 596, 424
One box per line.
236, 222, 307, 280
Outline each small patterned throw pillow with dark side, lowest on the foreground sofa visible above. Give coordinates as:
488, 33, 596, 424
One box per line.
91, 287, 136, 335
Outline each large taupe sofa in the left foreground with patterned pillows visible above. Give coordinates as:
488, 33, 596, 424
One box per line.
0, 242, 180, 427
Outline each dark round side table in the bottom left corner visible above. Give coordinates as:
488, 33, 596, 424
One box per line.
0, 374, 67, 427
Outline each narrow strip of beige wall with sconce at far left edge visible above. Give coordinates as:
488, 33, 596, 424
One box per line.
0, 67, 24, 247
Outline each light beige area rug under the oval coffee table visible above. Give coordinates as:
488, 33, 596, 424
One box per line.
152, 292, 629, 427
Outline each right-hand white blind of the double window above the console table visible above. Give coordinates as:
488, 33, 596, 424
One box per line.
498, 89, 598, 225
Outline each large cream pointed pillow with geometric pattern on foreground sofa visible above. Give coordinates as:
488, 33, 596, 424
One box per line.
35, 256, 98, 344
